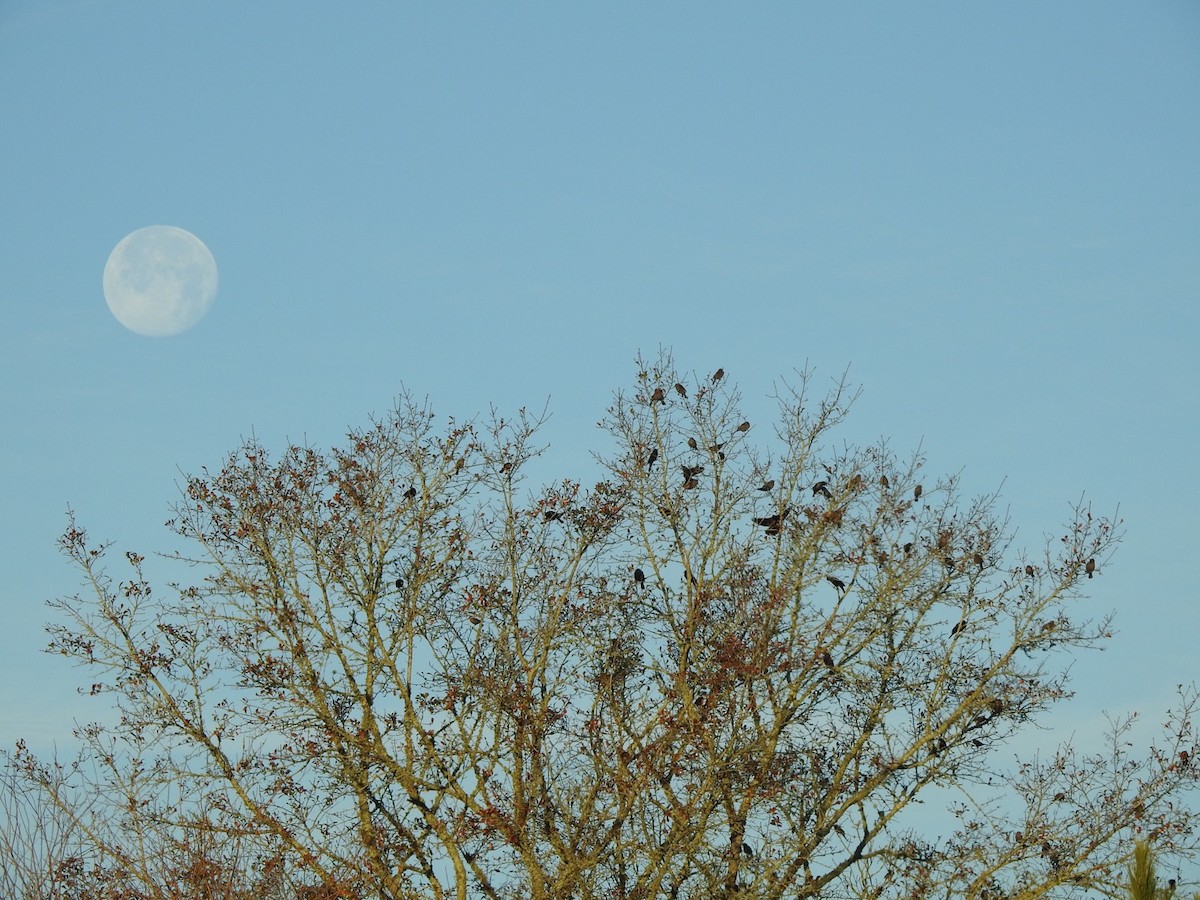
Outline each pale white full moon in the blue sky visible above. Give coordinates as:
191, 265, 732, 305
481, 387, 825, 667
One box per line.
104, 226, 217, 337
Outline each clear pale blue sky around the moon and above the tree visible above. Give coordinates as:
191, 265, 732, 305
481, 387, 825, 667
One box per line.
0, 0, 1200, 777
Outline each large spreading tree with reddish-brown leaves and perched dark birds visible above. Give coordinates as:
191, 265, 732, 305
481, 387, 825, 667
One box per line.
9, 356, 1196, 900
